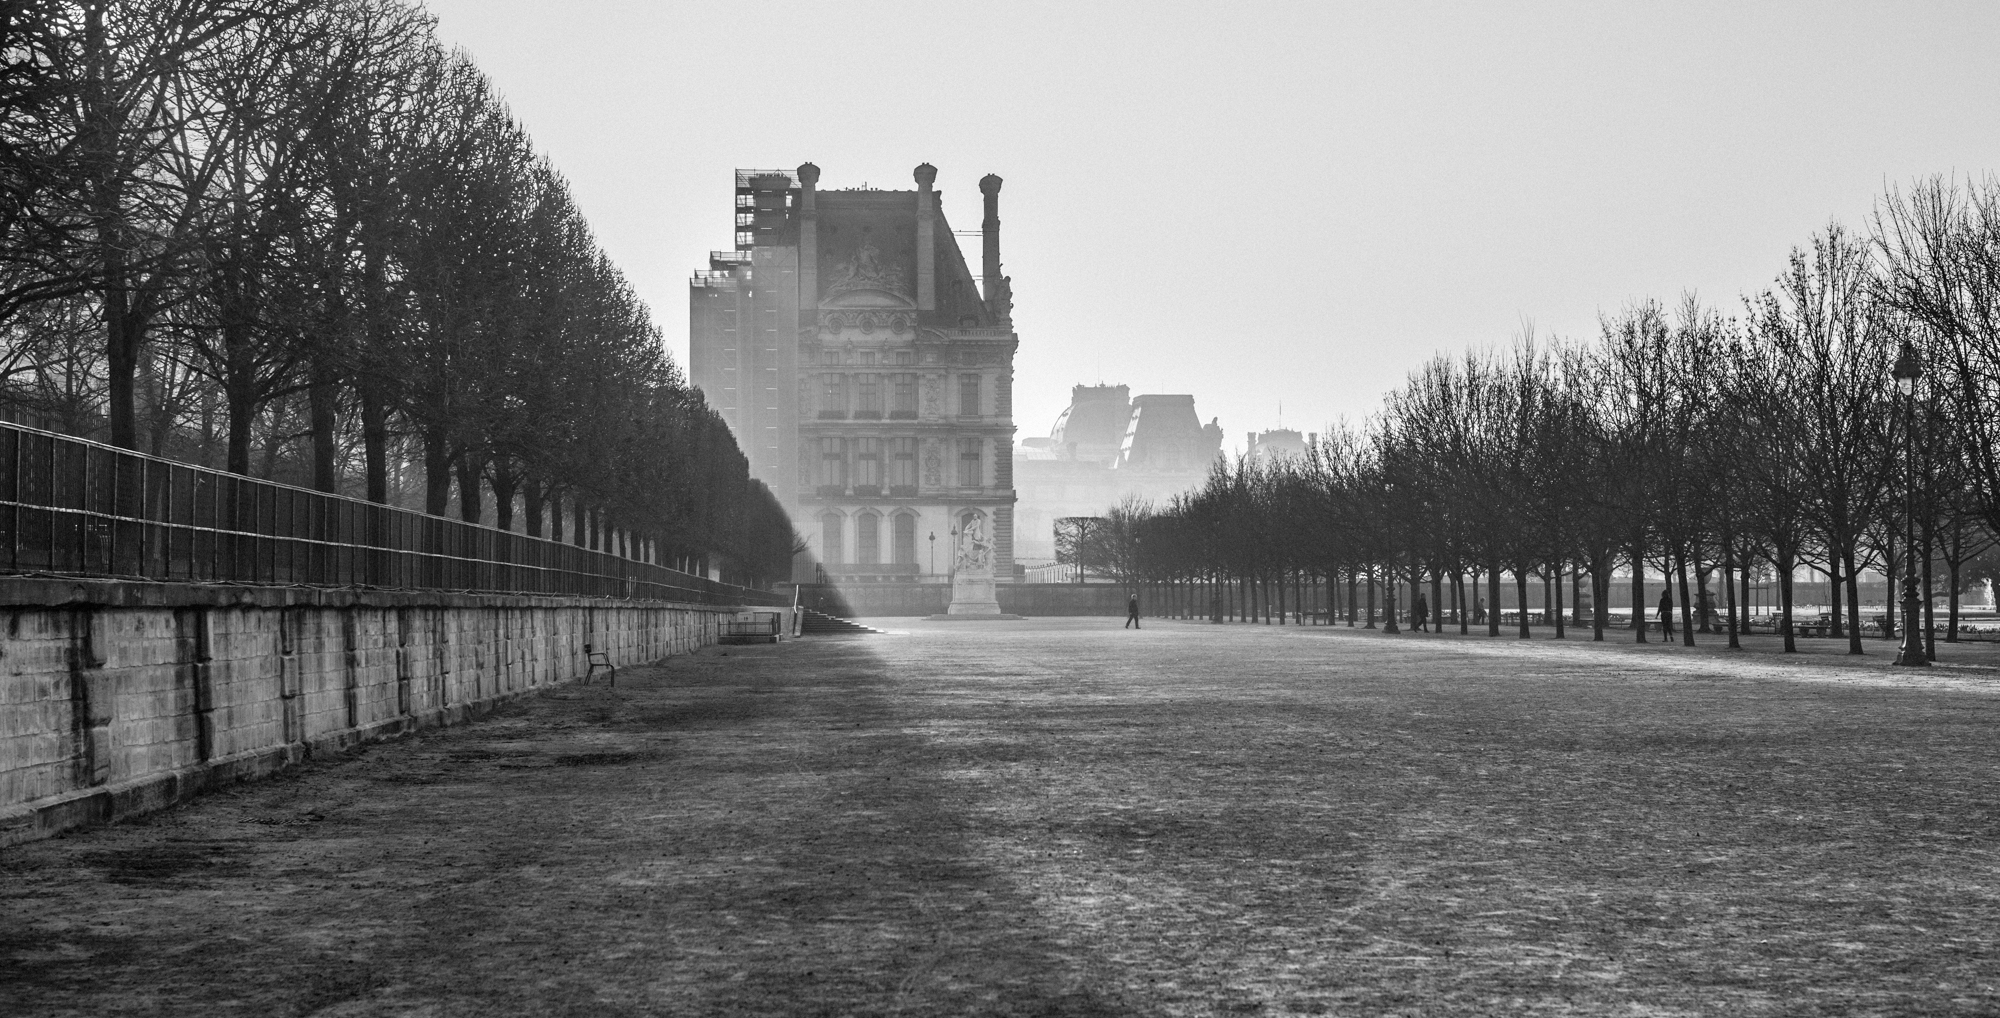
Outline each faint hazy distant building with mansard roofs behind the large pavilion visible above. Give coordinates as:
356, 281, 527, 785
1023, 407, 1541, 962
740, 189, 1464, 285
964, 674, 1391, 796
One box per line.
1014, 386, 1222, 562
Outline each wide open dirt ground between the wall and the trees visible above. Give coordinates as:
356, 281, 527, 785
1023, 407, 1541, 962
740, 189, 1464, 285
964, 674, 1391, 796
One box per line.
0, 620, 2000, 1018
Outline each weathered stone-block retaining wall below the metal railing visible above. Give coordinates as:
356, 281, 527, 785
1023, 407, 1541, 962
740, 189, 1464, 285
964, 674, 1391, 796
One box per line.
0, 578, 732, 844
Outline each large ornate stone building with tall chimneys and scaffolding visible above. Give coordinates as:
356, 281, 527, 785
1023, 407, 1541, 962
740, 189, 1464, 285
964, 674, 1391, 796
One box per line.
688, 162, 1018, 582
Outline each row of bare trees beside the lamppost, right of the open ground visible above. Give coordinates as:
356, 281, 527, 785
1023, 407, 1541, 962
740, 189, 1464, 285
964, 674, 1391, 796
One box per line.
1094, 178, 2000, 654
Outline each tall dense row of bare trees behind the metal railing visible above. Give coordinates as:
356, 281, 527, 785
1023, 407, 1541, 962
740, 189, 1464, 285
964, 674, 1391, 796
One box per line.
0, 0, 792, 576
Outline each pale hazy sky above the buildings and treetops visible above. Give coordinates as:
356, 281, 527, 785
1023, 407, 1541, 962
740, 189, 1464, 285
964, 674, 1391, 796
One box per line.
418, 0, 2000, 446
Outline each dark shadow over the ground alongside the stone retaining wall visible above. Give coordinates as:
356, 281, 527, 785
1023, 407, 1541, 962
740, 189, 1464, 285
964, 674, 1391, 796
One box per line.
0, 640, 1136, 1018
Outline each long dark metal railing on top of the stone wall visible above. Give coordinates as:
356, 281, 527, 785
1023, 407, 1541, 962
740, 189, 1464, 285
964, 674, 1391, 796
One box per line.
0, 422, 782, 604
